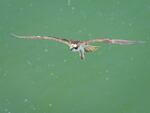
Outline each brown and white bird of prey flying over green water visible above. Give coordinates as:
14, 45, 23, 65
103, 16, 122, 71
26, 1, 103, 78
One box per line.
12, 34, 143, 59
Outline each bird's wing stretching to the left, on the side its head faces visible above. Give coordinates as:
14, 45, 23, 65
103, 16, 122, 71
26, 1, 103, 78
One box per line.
11, 34, 70, 46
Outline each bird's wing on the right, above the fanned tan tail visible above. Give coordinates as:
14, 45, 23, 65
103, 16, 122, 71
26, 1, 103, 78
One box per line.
83, 38, 143, 45
